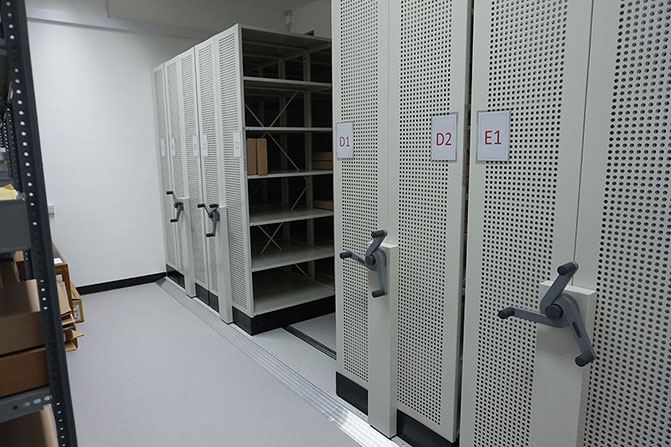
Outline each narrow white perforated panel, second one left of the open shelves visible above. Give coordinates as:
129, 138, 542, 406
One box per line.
197, 44, 219, 294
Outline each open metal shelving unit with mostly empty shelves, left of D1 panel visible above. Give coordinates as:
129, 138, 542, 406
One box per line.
202, 25, 334, 328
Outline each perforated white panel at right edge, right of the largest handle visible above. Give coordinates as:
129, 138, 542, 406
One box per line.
584, 0, 671, 447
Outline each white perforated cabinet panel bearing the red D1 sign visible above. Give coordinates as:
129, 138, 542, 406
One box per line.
332, 0, 389, 398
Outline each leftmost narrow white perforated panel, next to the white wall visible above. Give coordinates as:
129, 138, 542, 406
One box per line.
152, 65, 177, 268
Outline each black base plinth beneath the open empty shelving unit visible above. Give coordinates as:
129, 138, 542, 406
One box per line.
233, 297, 335, 335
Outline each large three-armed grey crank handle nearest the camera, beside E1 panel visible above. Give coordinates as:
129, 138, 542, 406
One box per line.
498, 262, 596, 368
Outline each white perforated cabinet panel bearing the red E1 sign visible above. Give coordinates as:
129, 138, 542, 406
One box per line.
461, 0, 591, 447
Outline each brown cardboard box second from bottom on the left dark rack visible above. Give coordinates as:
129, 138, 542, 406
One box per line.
0, 348, 49, 397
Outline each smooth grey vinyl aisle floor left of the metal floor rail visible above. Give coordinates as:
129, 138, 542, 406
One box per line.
68, 284, 358, 447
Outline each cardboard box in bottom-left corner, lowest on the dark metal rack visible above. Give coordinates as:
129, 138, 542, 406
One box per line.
0, 406, 58, 447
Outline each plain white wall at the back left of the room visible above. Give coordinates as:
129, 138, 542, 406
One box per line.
29, 22, 196, 286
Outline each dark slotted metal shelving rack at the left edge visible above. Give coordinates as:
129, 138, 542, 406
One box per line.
0, 0, 77, 447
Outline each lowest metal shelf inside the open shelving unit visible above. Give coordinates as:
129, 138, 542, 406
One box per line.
254, 271, 335, 315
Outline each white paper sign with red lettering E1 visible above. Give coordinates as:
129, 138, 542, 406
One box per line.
477, 111, 510, 161
